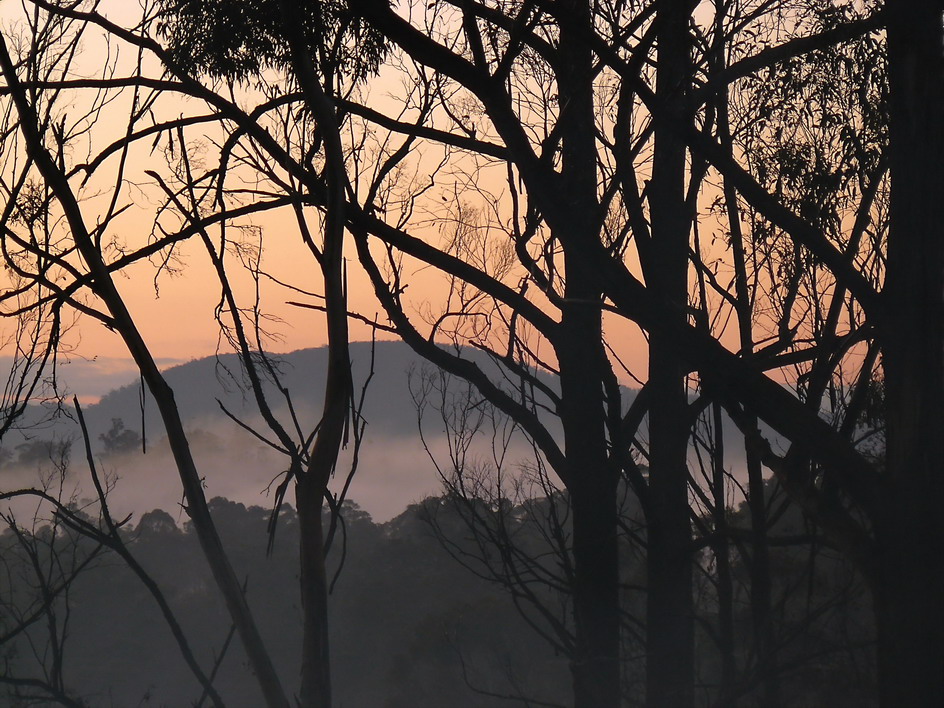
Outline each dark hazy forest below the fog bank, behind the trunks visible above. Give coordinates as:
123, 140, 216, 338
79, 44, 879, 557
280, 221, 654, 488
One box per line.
0, 494, 874, 708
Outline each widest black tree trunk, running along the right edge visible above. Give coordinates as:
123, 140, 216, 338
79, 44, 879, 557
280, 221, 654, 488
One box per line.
875, 2, 944, 706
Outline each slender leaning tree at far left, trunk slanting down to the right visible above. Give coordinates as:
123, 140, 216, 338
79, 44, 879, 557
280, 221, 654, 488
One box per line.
0, 15, 287, 705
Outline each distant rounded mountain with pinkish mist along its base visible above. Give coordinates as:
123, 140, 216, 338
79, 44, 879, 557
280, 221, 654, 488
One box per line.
0, 342, 553, 520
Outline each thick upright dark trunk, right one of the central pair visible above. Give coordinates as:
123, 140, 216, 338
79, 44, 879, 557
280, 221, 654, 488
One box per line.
643, 0, 694, 708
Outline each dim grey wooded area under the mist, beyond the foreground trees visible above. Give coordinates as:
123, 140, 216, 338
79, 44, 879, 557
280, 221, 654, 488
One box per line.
0, 486, 875, 708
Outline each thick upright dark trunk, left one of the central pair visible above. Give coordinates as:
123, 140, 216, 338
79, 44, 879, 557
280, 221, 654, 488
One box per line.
556, 0, 620, 708
